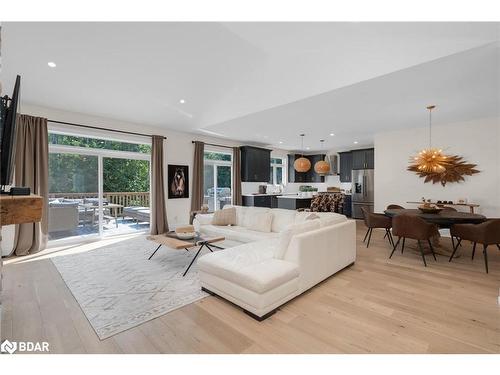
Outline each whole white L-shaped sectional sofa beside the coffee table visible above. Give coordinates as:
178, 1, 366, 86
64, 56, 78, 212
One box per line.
193, 206, 356, 320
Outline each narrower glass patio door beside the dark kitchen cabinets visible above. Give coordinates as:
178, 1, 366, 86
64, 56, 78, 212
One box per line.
203, 151, 233, 212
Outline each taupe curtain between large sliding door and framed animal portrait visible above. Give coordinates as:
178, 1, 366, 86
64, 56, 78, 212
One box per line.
151, 135, 168, 234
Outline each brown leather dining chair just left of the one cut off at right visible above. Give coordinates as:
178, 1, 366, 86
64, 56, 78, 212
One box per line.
389, 215, 439, 267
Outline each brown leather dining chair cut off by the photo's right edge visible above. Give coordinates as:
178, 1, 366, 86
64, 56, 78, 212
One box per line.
449, 219, 500, 273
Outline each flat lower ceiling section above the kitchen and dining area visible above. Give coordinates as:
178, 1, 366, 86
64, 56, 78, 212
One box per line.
208, 43, 500, 151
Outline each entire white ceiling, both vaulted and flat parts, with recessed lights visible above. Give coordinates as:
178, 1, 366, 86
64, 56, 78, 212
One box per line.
1, 23, 500, 149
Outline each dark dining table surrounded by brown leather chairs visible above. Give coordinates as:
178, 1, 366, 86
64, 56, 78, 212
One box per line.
384, 208, 486, 258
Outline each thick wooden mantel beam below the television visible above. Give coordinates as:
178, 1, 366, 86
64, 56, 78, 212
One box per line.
0, 194, 43, 342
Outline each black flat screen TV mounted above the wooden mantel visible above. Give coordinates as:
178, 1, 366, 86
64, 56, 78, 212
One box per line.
0, 76, 21, 191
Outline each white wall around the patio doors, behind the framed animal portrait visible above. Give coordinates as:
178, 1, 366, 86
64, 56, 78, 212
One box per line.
2, 104, 239, 253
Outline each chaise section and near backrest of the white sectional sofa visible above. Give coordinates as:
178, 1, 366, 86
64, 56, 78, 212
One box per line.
198, 209, 356, 320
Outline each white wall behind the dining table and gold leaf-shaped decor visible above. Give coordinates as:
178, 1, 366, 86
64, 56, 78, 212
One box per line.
375, 118, 500, 217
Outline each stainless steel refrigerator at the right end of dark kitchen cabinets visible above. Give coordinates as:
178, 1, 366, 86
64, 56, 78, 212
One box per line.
351, 169, 374, 219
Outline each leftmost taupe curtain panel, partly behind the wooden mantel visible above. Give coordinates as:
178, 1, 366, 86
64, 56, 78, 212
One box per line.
14, 115, 49, 255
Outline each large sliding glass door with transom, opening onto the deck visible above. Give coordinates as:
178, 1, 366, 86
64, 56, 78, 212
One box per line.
49, 132, 151, 244
